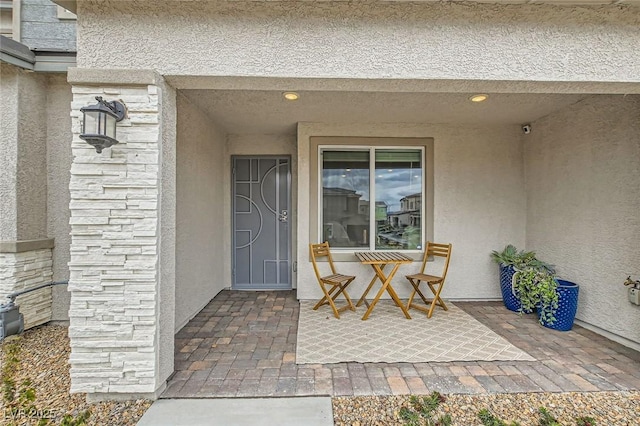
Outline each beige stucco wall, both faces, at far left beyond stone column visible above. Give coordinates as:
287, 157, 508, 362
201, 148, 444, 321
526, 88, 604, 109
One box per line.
0, 70, 71, 321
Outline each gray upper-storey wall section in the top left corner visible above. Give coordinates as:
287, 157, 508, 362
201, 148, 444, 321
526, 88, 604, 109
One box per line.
20, 0, 76, 51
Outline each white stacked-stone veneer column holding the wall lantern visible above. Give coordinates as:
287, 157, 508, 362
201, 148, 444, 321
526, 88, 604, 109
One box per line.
69, 74, 173, 399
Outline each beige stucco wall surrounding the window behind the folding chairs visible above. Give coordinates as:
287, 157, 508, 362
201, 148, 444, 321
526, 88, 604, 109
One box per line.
297, 123, 525, 299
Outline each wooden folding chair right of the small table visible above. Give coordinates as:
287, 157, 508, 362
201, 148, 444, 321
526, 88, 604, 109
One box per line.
406, 241, 451, 318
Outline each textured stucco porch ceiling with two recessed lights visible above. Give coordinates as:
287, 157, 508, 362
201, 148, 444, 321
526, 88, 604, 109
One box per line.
181, 90, 589, 134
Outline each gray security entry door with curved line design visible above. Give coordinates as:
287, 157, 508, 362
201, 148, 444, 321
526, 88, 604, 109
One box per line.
232, 157, 291, 290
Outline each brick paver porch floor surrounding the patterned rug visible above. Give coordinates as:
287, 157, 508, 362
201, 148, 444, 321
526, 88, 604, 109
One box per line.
162, 291, 640, 398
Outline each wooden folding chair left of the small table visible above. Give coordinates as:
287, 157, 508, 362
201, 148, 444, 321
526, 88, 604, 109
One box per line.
309, 241, 356, 319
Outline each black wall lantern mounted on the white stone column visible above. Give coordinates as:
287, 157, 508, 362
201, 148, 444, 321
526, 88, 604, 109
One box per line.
80, 96, 127, 154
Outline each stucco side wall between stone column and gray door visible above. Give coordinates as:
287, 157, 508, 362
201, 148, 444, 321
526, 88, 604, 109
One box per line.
175, 94, 229, 331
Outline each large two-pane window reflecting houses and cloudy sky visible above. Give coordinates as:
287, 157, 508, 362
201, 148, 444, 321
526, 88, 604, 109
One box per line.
319, 146, 425, 250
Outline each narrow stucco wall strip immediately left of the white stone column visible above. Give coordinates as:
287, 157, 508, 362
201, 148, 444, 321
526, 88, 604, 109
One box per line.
47, 74, 72, 321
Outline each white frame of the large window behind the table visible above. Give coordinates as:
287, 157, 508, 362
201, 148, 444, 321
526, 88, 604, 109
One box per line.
316, 144, 429, 254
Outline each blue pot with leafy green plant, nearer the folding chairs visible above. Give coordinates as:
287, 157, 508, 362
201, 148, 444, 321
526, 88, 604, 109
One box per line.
491, 244, 554, 312
